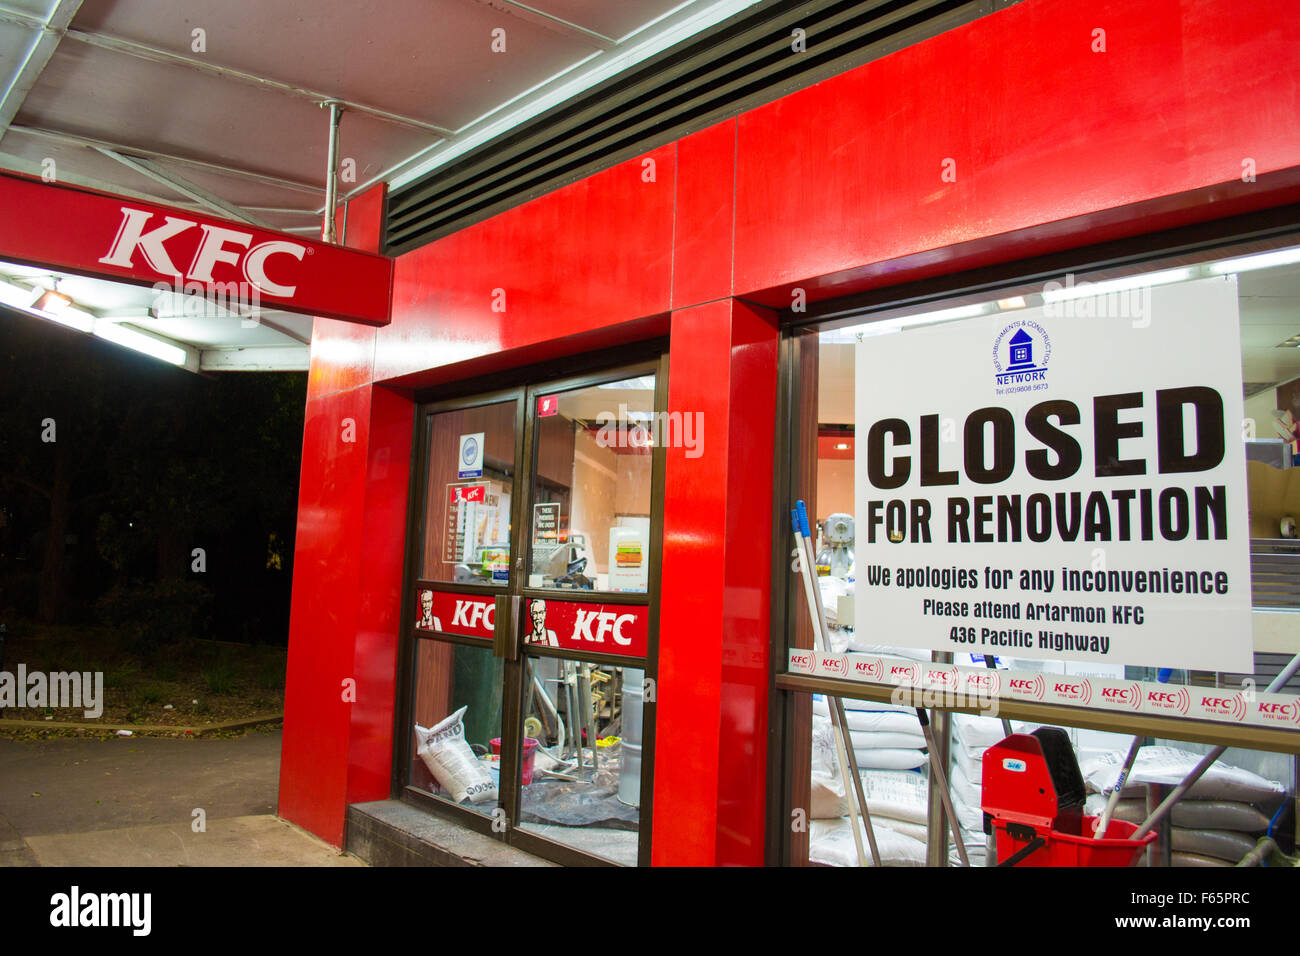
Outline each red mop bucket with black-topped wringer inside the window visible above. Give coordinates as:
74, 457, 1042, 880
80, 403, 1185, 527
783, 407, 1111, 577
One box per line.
982, 727, 1156, 866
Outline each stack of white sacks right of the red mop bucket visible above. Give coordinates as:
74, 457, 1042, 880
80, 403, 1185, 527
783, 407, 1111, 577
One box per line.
1080, 747, 1286, 866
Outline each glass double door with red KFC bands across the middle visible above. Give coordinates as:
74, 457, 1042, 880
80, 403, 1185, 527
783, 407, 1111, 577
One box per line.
399, 362, 666, 865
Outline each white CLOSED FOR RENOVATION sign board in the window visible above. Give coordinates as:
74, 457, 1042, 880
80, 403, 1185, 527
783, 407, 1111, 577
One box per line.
854, 276, 1253, 672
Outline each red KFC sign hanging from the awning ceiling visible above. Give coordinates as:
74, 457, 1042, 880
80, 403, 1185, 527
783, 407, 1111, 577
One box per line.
0, 172, 393, 325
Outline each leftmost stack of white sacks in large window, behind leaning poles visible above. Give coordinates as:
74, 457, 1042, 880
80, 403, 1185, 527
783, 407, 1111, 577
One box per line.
809, 700, 928, 866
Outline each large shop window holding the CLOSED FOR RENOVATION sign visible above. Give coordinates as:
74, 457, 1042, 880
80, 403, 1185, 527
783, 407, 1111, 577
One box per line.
777, 246, 1300, 866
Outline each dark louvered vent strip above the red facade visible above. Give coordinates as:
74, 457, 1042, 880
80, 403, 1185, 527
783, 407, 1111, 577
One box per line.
385, 0, 1011, 255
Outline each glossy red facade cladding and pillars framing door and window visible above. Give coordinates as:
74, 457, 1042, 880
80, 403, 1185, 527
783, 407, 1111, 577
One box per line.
281, 0, 1300, 865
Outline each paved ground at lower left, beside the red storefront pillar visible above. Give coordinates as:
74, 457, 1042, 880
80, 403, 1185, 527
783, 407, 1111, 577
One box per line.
0, 728, 365, 866
